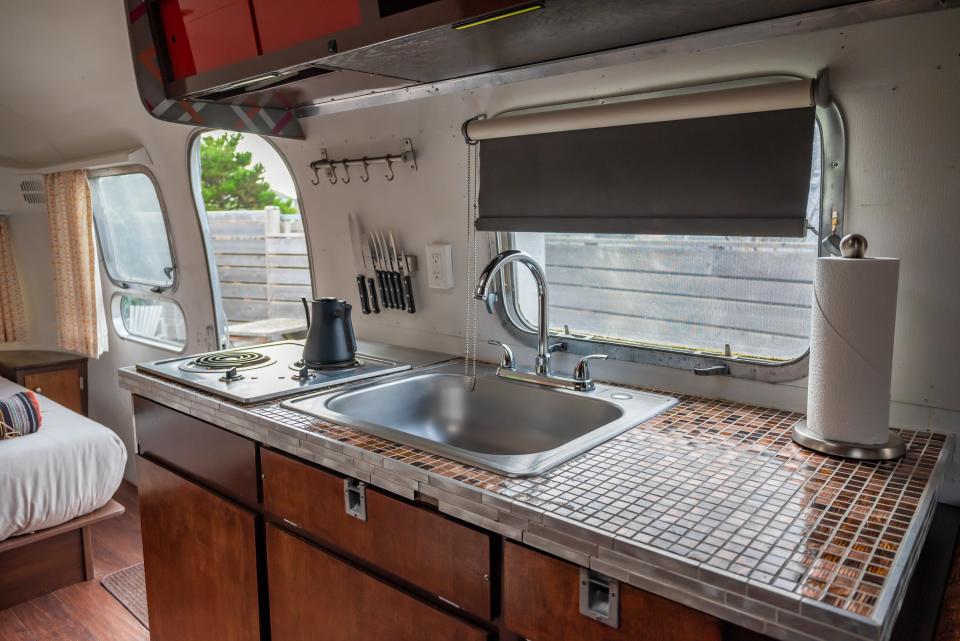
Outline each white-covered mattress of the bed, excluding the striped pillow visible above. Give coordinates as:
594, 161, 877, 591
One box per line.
0, 378, 127, 541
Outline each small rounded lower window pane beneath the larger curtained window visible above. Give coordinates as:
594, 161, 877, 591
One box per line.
111, 294, 187, 352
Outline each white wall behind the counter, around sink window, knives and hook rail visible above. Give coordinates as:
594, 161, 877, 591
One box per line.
279, 10, 960, 496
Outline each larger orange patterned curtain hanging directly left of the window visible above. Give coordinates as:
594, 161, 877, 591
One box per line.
44, 170, 106, 358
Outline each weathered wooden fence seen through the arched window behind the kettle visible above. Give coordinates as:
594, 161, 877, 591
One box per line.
207, 208, 311, 323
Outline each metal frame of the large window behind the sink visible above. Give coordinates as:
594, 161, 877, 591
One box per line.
490, 99, 846, 383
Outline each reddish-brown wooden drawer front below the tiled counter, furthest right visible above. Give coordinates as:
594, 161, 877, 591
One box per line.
503, 542, 721, 641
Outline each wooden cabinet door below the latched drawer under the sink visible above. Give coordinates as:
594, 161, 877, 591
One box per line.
266, 524, 487, 641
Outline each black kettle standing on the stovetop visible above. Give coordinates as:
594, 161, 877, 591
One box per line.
301, 297, 357, 369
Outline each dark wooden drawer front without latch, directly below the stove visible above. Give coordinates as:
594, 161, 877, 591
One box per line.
133, 396, 259, 509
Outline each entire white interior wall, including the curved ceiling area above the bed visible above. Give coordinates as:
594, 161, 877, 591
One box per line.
0, 0, 960, 495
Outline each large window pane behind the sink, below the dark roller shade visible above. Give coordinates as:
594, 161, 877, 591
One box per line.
500, 119, 829, 367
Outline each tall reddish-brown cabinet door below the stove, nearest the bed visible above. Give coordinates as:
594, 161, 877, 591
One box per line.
139, 457, 260, 641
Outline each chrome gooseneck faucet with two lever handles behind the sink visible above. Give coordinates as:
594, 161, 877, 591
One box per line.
473, 249, 607, 392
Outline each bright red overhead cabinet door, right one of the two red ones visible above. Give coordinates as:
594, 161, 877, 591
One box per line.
253, 0, 363, 53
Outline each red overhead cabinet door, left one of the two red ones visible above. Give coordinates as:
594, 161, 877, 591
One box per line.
159, 0, 260, 80
